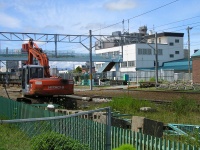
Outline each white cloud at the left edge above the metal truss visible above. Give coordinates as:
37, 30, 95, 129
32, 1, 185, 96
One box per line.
0, 13, 20, 28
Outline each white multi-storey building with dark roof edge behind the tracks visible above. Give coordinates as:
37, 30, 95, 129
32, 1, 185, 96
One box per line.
95, 32, 185, 72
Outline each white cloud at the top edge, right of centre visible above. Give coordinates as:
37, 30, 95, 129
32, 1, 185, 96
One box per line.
105, 0, 136, 10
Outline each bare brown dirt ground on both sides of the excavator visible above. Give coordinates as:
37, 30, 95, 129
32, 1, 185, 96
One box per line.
0, 85, 200, 102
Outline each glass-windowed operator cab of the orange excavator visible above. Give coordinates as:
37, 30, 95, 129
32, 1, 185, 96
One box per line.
22, 65, 44, 95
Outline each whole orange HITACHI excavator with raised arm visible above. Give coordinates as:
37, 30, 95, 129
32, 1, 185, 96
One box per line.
22, 39, 74, 97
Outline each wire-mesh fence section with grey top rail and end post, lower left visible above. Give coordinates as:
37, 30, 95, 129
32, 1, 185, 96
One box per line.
0, 108, 111, 150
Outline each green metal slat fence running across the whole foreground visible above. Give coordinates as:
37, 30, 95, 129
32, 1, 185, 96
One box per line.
0, 97, 200, 150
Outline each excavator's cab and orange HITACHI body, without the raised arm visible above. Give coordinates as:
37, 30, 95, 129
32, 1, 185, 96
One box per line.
22, 65, 74, 97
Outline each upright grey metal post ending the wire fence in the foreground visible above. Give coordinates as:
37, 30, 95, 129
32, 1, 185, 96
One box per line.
105, 107, 111, 150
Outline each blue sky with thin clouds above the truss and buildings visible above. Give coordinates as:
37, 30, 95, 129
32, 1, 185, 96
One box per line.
0, 0, 200, 68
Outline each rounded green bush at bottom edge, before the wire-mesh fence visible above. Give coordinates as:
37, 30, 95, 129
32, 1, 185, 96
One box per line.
31, 132, 89, 150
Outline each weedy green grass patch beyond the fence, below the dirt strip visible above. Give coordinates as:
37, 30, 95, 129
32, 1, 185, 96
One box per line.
92, 96, 200, 125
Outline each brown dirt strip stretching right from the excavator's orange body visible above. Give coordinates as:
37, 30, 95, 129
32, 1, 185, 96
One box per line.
75, 85, 200, 102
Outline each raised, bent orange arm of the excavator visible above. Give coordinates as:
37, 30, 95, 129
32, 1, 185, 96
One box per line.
22, 39, 50, 78
